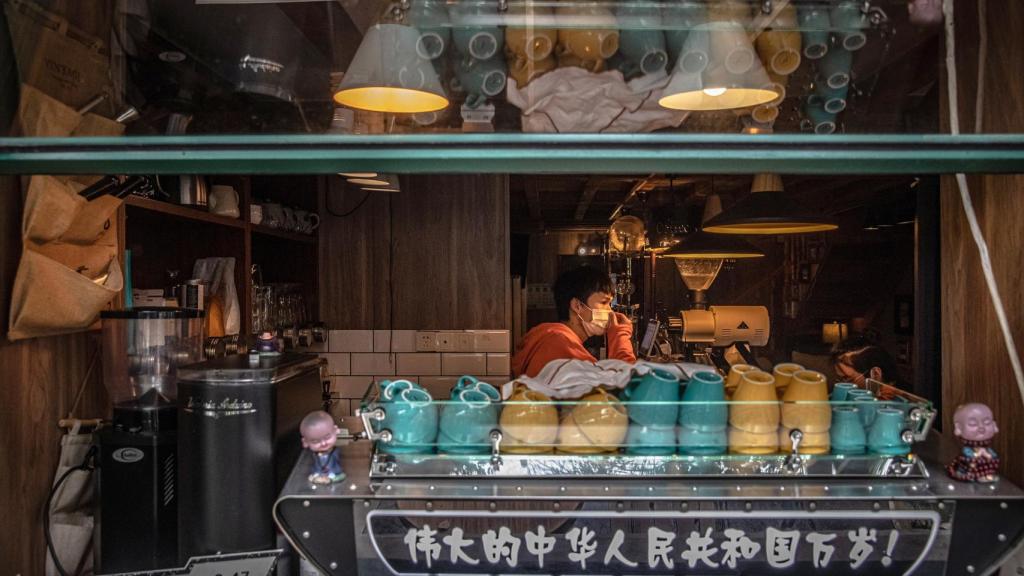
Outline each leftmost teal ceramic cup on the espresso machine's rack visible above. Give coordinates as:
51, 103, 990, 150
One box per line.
378, 380, 437, 454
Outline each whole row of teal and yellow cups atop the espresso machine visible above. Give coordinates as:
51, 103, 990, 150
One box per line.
368, 364, 909, 455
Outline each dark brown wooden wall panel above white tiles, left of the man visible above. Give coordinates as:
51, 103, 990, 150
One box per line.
319, 174, 511, 330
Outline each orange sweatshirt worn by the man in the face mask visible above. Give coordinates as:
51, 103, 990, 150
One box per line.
512, 322, 637, 377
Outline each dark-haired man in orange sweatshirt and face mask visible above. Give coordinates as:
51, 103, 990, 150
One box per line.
512, 266, 636, 376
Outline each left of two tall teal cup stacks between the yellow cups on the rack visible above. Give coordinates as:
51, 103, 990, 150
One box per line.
623, 369, 679, 456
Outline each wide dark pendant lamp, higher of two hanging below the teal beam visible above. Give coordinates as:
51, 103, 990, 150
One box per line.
703, 174, 839, 234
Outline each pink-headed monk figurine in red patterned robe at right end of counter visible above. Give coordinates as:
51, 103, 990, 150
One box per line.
946, 404, 999, 482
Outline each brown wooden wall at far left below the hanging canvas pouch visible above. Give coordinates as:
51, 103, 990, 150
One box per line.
0, 176, 110, 574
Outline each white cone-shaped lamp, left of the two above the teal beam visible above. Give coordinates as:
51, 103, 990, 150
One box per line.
334, 24, 449, 114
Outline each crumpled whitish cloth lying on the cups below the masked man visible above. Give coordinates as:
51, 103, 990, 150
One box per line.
502, 360, 715, 400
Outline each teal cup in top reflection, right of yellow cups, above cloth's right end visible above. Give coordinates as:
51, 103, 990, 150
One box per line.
615, 1, 669, 76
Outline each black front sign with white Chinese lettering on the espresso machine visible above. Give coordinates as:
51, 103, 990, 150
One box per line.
368, 509, 944, 576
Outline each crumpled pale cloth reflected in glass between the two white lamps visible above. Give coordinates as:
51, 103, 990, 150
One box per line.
506, 67, 688, 132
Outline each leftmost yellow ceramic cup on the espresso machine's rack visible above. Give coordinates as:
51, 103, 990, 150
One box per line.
500, 385, 558, 454
